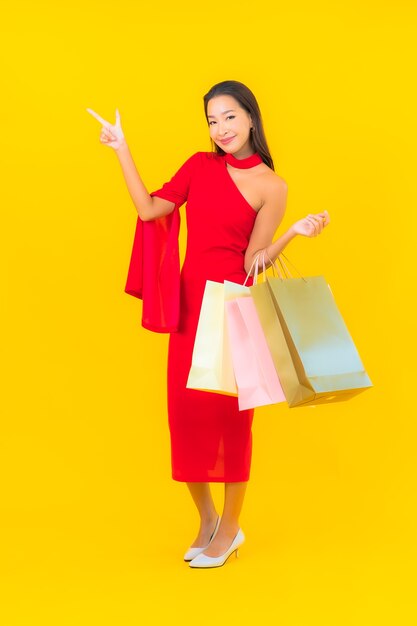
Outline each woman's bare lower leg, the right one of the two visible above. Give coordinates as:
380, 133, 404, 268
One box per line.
204, 481, 248, 556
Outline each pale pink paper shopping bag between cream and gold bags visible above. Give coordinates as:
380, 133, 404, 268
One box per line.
225, 296, 285, 411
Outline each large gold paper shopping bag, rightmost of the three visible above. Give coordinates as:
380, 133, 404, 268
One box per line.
250, 255, 373, 407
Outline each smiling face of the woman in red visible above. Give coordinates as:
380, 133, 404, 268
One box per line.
207, 96, 253, 158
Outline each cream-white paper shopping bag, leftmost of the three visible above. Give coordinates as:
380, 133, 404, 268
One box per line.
186, 280, 249, 396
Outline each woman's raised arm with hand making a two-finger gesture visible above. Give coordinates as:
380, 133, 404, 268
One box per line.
87, 109, 175, 222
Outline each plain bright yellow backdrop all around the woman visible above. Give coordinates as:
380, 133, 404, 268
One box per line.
0, 0, 417, 626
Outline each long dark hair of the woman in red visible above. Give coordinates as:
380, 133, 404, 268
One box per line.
204, 80, 275, 171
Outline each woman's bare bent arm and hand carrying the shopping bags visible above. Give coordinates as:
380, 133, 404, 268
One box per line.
245, 179, 330, 272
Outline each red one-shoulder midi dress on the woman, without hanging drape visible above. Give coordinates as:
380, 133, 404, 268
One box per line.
150, 152, 257, 482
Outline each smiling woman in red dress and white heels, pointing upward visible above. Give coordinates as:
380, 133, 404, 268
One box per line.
87, 80, 330, 567
